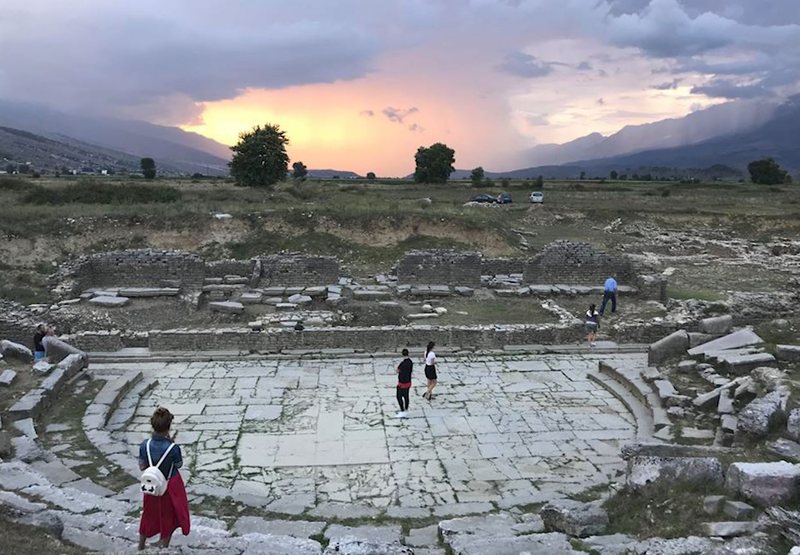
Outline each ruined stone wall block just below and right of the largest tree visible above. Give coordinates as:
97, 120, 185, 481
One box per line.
258, 253, 341, 287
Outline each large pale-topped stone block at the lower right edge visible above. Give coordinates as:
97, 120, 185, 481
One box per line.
725, 461, 800, 507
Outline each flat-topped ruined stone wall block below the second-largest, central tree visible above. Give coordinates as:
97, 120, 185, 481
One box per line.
397, 250, 482, 287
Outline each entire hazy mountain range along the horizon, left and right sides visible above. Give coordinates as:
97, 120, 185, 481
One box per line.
0, 95, 800, 179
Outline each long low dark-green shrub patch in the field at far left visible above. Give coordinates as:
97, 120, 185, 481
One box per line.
22, 179, 181, 205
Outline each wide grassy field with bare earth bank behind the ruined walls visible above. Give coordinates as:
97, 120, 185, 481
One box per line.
0, 177, 800, 302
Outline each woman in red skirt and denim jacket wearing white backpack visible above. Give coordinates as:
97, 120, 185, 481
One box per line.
139, 407, 189, 550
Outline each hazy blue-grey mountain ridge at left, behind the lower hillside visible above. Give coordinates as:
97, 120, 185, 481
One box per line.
0, 100, 230, 175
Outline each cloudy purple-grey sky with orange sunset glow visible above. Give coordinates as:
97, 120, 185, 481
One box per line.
0, 0, 800, 176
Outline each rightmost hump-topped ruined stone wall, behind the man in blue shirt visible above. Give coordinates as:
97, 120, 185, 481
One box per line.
523, 241, 636, 285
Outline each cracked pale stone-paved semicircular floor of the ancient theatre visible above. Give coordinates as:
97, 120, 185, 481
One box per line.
120, 354, 646, 513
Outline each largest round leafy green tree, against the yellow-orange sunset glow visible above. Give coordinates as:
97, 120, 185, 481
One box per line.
228, 123, 289, 187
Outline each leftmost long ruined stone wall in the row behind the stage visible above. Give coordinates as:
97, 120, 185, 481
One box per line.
57, 249, 206, 294
